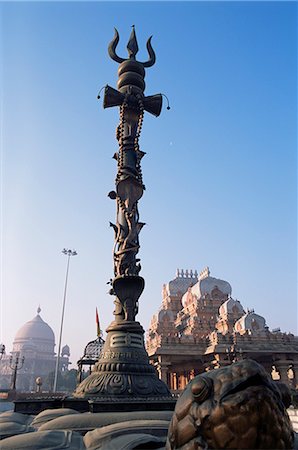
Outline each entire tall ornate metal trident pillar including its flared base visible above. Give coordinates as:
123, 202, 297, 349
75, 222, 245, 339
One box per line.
74, 27, 171, 401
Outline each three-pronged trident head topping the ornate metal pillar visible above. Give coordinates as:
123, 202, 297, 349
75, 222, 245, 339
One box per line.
108, 25, 156, 67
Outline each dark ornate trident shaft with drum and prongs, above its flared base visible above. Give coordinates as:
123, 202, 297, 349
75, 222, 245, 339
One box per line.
103, 27, 162, 321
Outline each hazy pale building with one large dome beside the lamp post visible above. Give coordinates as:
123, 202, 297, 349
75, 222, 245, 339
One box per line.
0, 307, 70, 392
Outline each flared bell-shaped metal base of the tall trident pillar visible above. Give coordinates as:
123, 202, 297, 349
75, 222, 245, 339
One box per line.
73, 321, 171, 402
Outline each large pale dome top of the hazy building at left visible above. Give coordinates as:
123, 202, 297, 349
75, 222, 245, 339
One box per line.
14, 314, 55, 344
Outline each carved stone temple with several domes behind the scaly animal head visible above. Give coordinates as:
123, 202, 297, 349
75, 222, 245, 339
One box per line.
146, 267, 298, 393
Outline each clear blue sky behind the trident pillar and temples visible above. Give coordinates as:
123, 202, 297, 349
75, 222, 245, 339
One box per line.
0, 2, 297, 363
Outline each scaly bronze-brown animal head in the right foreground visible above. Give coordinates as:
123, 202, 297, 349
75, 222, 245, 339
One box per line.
166, 359, 294, 450
